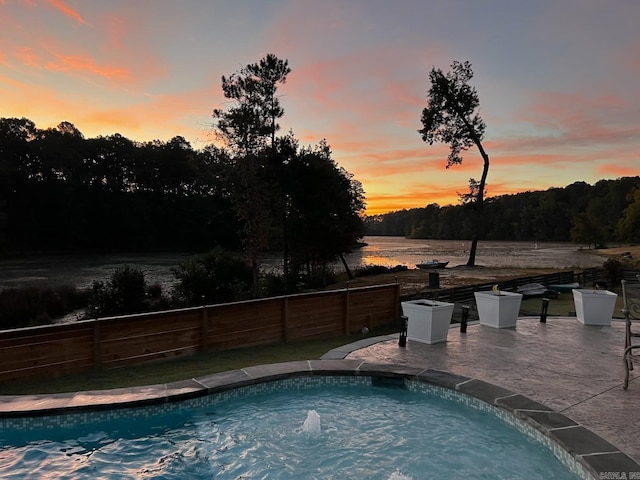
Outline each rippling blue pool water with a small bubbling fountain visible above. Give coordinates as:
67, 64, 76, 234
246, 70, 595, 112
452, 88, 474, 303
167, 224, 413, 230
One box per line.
0, 385, 578, 480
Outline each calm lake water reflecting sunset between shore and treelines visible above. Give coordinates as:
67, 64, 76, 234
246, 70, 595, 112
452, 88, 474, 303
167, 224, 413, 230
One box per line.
0, 237, 605, 291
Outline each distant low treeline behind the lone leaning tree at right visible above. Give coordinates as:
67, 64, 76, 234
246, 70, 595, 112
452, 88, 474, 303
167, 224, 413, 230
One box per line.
365, 177, 640, 245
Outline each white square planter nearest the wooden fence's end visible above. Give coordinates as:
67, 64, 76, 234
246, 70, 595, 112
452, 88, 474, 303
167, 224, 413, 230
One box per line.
402, 299, 454, 344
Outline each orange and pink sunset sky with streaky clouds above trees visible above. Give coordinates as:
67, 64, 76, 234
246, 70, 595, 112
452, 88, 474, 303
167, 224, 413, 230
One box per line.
0, 0, 640, 215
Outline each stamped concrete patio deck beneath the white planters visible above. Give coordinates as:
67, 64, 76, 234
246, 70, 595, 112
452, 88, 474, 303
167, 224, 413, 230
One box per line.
325, 317, 640, 466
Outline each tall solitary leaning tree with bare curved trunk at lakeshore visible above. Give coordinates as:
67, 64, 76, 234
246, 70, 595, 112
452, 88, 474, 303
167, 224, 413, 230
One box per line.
418, 61, 489, 267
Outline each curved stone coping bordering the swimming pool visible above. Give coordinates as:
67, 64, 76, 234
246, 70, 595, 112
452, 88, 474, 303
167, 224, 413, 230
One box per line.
0, 354, 640, 479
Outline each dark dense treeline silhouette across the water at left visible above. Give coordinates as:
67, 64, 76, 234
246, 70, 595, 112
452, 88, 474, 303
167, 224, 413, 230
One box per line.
0, 118, 250, 252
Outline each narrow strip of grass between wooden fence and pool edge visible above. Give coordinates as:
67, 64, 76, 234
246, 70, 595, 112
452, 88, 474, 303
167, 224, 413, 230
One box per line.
0, 327, 398, 395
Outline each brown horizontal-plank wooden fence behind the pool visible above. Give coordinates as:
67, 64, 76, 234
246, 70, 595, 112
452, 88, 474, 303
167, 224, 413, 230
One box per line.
0, 284, 399, 381
